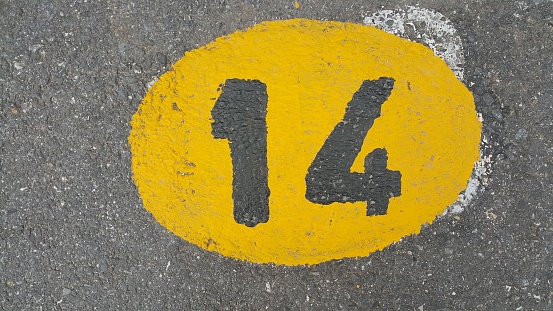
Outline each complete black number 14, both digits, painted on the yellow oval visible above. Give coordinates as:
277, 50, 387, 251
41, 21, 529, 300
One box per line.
211, 78, 401, 227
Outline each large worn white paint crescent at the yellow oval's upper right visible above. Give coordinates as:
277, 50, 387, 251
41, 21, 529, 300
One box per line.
363, 6, 465, 81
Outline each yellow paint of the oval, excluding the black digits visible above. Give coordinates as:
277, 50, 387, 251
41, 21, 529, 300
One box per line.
129, 19, 481, 265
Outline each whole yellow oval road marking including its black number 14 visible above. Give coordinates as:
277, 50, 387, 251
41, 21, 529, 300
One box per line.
129, 19, 481, 265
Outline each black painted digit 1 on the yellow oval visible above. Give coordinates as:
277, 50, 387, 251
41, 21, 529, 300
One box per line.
211, 79, 270, 227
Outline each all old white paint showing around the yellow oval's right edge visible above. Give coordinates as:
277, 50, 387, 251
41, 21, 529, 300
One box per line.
363, 6, 491, 216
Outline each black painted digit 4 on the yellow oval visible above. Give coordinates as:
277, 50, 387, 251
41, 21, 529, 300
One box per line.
305, 78, 401, 216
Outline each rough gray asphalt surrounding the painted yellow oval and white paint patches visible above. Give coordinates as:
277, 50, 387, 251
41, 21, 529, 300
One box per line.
0, 0, 553, 310
